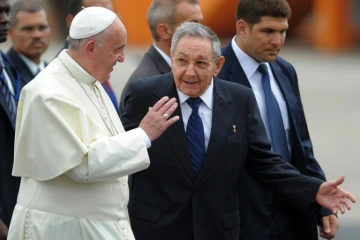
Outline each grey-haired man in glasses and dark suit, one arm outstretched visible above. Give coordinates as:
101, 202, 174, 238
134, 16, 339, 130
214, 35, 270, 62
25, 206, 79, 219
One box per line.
121, 22, 355, 240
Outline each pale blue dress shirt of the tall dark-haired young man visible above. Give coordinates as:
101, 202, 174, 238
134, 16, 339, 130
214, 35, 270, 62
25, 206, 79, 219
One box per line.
231, 37, 292, 156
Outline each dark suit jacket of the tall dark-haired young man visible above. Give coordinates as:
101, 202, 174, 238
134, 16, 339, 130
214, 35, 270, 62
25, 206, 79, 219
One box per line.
218, 42, 331, 240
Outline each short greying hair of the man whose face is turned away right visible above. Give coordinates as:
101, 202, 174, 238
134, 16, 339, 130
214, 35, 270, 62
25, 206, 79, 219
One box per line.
147, 0, 199, 41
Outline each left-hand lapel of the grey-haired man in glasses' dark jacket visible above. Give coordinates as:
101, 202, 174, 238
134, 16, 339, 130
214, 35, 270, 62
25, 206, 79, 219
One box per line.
154, 73, 195, 182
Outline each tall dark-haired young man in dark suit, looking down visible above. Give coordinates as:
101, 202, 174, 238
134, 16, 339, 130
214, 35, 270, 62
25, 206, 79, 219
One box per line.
218, 0, 338, 240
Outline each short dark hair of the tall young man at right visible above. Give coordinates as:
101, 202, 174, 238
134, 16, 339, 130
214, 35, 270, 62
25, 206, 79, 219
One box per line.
236, 0, 291, 25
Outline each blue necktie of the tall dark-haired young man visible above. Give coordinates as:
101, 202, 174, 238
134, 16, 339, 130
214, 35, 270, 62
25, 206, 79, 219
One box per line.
258, 64, 290, 162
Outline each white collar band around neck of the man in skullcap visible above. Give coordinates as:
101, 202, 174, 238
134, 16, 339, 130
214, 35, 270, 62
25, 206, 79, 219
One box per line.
58, 49, 96, 85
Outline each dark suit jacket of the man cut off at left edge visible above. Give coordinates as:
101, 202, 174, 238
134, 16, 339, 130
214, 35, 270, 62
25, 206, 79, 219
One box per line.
0, 50, 20, 226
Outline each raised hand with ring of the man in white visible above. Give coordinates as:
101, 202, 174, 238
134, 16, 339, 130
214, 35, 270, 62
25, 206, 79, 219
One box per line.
139, 97, 180, 141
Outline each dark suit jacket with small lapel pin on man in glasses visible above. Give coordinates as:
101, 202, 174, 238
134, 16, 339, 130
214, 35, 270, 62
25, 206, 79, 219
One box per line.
121, 73, 321, 240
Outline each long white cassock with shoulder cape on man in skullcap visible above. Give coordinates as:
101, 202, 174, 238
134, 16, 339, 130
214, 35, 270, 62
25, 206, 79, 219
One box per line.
8, 50, 150, 240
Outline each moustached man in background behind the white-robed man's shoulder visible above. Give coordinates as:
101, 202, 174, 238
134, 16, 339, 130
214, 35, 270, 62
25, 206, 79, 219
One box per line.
6, 0, 50, 84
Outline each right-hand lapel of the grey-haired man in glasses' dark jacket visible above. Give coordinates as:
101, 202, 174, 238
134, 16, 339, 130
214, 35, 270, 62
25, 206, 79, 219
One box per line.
198, 77, 234, 181
